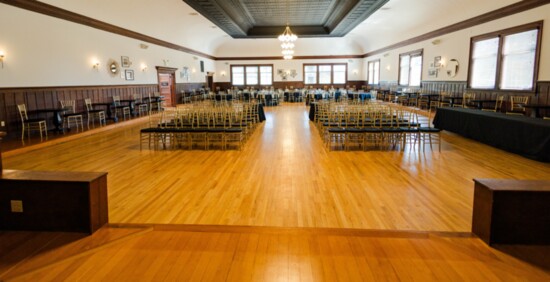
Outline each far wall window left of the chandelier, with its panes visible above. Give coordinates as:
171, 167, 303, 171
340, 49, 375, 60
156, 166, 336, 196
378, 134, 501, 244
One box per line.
231, 65, 273, 86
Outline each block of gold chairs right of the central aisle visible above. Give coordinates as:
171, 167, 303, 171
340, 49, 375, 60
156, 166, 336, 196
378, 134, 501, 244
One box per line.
316, 102, 441, 151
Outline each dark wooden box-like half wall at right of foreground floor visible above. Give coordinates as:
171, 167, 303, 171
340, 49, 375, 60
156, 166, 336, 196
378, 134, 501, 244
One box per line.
472, 179, 550, 245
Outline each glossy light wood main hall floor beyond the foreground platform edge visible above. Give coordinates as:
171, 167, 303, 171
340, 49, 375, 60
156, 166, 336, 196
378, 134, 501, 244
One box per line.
4, 104, 550, 232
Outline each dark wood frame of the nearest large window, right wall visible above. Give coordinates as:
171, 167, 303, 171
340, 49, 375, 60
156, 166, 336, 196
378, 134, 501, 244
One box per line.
466, 21, 543, 93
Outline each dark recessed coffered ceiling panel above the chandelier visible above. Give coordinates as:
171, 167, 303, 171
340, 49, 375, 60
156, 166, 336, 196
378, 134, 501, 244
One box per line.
183, 0, 389, 38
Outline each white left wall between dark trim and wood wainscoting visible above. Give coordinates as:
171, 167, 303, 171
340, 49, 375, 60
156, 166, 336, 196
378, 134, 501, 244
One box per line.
0, 4, 215, 87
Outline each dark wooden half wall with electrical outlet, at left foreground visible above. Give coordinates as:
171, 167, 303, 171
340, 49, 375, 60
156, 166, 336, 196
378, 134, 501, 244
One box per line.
0, 170, 109, 234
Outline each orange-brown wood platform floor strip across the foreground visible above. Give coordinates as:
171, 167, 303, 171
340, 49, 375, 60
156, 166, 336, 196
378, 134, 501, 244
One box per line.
0, 225, 550, 281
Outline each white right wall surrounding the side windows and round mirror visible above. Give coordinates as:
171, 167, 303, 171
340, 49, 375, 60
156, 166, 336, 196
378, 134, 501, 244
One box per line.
362, 5, 550, 82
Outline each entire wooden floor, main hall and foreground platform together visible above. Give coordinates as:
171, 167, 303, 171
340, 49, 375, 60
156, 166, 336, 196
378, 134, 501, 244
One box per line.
0, 104, 550, 281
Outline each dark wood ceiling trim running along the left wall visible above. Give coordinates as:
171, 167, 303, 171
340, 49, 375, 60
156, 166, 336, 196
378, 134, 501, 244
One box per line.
0, 0, 216, 60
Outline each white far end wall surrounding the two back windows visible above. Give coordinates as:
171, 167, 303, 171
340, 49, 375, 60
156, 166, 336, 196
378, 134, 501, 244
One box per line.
214, 59, 363, 82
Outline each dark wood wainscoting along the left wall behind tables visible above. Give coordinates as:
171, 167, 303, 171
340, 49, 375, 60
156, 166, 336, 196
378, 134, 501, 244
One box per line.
0, 84, 158, 136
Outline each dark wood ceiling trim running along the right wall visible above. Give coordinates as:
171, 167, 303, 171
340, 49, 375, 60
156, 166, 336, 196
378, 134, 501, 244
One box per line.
363, 0, 550, 58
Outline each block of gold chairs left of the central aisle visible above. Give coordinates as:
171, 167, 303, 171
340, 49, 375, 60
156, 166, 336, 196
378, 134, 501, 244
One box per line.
140, 103, 259, 150
